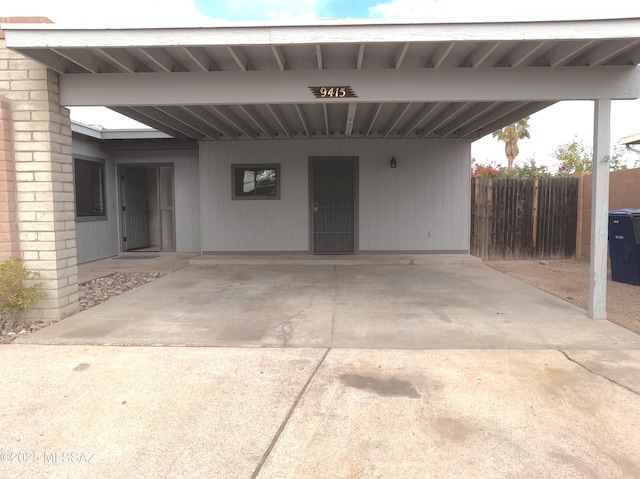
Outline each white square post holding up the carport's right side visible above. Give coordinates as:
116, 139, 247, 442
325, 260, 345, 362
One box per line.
589, 99, 611, 319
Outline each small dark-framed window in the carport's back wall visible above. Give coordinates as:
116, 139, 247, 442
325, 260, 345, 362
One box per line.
231, 164, 280, 200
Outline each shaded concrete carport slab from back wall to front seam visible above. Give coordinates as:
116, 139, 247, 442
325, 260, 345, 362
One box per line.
15, 256, 640, 349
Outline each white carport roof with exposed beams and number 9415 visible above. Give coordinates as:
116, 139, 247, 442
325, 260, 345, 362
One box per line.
2, 18, 640, 140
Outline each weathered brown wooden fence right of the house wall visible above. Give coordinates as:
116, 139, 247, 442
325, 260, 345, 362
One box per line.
471, 177, 578, 259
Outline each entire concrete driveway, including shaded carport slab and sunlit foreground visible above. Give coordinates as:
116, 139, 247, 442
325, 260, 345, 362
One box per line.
0, 259, 640, 479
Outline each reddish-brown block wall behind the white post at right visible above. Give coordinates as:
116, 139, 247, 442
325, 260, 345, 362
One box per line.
576, 168, 640, 260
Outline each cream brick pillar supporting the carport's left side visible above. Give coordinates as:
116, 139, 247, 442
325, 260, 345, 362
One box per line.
0, 18, 78, 319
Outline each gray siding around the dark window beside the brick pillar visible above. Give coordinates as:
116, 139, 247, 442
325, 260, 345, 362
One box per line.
72, 135, 118, 263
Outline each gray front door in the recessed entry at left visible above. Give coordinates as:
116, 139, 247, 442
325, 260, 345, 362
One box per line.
120, 168, 149, 251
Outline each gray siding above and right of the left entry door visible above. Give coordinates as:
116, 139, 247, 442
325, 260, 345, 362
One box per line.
112, 150, 201, 252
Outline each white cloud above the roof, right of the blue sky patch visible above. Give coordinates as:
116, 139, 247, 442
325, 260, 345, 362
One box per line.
369, 0, 640, 19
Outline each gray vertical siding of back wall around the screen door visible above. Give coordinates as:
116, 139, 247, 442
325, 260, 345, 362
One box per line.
200, 139, 471, 252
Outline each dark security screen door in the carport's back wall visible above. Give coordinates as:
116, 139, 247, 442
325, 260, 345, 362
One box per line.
309, 158, 358, 254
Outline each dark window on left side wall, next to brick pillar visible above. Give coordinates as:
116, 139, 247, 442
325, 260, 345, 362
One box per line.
74, 158, 106, 219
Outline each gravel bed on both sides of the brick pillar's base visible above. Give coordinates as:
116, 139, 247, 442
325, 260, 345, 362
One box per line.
0, 273, 166, 344
